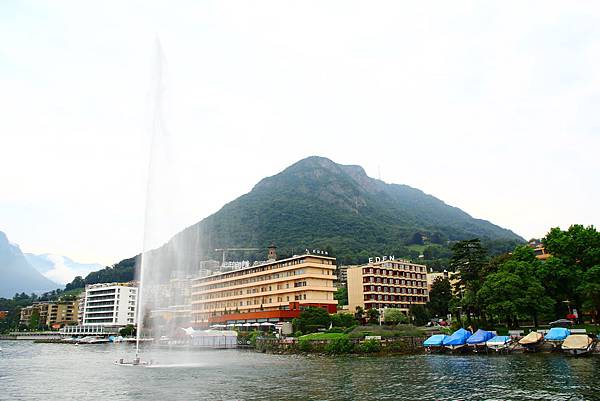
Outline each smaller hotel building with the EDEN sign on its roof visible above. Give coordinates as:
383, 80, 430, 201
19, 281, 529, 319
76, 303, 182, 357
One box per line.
348, 257, 428, 312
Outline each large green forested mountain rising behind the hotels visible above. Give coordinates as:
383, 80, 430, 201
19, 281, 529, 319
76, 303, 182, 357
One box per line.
138, 156, 524, 269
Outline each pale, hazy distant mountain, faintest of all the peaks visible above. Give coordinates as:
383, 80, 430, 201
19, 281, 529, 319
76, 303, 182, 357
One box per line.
25, 253, 104, 284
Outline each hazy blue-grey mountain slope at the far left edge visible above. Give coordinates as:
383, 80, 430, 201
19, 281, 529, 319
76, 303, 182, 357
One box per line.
0, 231, 59, 298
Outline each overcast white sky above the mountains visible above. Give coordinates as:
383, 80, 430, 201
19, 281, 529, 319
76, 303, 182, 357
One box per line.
0, 0, 600, 265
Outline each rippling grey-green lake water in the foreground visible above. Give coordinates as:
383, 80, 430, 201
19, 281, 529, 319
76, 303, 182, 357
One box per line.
0, 341, 600, 401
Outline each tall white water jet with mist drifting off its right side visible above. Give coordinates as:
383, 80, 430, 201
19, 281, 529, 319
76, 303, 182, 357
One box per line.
131, 38, 214, 361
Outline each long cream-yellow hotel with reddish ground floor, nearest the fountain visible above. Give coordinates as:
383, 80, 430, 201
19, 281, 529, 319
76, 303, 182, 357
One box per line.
191, 254, 337, 328
